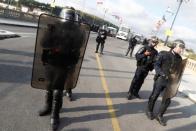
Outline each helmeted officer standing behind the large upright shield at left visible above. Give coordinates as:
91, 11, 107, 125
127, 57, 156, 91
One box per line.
39, 8, 83, 130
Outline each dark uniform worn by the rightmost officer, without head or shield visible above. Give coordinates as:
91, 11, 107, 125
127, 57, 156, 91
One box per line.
147, 51, 182, 126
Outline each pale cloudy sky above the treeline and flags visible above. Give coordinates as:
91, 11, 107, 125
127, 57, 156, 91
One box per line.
36, 0, 196, 51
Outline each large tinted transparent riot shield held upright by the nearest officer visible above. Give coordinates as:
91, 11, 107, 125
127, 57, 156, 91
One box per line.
31, 14, 90, 89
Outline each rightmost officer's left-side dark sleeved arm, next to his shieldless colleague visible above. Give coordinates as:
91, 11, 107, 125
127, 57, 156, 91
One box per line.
154, 52, 165, 76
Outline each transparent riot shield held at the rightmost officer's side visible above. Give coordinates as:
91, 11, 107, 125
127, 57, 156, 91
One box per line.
163, 59, 188, 100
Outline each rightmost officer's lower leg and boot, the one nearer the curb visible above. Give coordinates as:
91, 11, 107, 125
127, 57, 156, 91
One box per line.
156, 98, 171, 126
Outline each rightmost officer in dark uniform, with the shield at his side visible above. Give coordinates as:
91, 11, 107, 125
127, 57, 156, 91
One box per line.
146, 40, 185, 126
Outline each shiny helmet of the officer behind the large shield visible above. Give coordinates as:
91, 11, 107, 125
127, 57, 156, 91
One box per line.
60, 7, 78, 22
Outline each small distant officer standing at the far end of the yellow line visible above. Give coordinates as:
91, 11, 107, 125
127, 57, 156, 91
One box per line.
95, 25, 107, 54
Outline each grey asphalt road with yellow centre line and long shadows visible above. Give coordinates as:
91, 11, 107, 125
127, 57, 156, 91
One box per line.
0, 26, 196, 131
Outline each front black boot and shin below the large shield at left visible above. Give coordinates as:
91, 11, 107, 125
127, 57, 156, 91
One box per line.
50, 90, 63, 131
